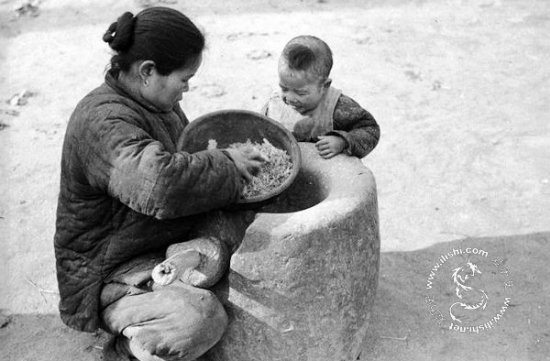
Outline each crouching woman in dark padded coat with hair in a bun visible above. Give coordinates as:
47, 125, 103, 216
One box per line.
55, 7, 262, 360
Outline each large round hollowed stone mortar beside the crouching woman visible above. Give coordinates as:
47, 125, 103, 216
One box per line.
205, 143, 380, 361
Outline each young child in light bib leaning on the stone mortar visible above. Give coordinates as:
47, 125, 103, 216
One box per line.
262, 35, 380, 159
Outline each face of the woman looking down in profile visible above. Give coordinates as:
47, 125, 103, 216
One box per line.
142, 55, 202, 112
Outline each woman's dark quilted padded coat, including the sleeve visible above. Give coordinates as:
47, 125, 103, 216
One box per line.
54, 73, 242, 332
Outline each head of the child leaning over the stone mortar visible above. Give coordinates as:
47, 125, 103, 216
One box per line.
279, 35, 332, 114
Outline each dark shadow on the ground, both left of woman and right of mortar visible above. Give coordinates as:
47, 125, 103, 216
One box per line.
0, 232, 550, 361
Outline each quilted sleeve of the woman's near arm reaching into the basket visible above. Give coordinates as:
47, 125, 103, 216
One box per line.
78, 108, 243, 219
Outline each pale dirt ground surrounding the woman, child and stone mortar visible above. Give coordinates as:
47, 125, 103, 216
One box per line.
0, 0, 550, 361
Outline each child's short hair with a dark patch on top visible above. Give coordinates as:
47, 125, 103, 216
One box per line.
282, 35, 332, 79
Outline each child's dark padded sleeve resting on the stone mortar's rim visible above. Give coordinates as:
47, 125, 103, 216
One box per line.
327, 94, 380, 158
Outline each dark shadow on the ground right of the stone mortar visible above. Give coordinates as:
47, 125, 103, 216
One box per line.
361, 232, 550, 361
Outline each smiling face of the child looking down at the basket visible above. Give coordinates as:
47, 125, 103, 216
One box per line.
279, 63, 330, 114
